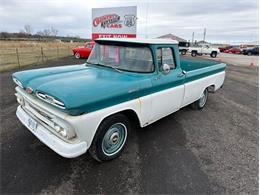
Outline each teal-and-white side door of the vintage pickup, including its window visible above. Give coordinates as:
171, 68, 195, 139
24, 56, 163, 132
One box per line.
151, 47, 185, 121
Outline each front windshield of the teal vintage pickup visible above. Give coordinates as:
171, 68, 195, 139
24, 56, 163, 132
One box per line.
87, 43, 154, 73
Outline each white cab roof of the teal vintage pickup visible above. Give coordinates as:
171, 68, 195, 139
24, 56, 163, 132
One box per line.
95, 38, 178, 44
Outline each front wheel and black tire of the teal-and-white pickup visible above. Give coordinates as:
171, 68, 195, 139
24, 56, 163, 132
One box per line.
89, 114, 131, 162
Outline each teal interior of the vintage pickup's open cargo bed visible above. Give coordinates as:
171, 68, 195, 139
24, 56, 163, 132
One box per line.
180, 57, 220, 72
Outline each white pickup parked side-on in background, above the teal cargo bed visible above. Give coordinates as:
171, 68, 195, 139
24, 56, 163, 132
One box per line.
189, 45, 220, 58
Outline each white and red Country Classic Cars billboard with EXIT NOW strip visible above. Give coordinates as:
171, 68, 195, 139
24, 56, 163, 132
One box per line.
92, 6, 137, 40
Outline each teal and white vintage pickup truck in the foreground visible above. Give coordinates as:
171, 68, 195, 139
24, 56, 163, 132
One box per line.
13, 39, 226, 161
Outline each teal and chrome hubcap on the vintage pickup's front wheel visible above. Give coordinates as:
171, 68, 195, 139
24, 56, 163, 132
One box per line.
102, 123, 127, 156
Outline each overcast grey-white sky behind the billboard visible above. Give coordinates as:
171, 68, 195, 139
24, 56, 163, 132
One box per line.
0, 0, 259, 43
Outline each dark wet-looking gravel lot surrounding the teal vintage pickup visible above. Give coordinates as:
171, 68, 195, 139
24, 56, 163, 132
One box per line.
0, 57, 258, 194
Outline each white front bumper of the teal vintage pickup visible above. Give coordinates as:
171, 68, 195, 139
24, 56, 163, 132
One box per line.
16, 106, 87, 158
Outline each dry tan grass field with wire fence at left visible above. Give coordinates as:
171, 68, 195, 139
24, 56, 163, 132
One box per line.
0, 45, 74, 72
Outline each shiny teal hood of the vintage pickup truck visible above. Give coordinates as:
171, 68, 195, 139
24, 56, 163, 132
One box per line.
13, 64, 151, 115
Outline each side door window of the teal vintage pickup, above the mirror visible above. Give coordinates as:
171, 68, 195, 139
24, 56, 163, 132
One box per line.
157, 47, 176, 70
